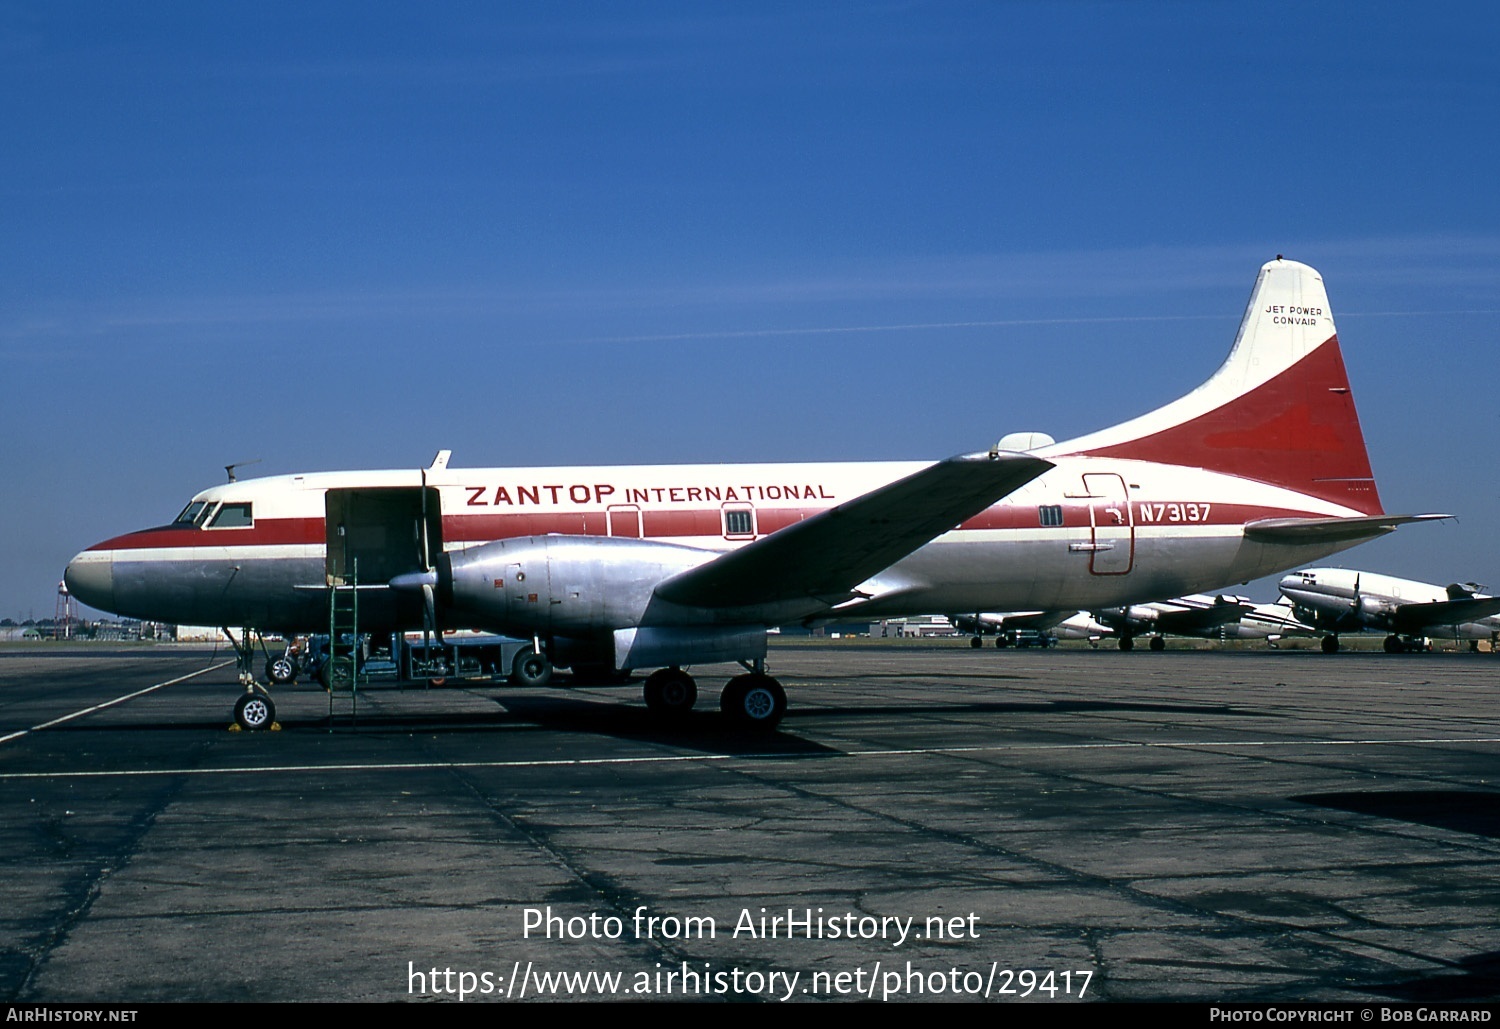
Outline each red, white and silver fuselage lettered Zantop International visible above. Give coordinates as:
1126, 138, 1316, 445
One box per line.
69, 458, 1370, 632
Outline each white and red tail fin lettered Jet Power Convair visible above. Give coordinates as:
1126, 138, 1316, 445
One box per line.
1041, 257, 1383, 515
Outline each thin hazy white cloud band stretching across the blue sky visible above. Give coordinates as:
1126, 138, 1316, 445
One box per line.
0, 236, 1500, 354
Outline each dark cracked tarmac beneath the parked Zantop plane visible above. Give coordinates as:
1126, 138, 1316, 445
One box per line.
0, 641, 1500, 1004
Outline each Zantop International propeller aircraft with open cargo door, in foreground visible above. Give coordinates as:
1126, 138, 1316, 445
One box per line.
66, 265, 1425, 726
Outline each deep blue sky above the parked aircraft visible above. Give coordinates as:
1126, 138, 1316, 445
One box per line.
0, 2, 1500, 618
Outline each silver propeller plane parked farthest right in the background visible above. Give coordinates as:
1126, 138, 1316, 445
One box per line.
1280, 569, 1500, 654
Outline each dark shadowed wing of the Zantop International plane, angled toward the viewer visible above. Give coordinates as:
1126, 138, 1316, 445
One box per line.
656, 452, 1052, 608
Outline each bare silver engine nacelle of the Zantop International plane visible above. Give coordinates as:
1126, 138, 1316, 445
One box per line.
438, 536, 717, 638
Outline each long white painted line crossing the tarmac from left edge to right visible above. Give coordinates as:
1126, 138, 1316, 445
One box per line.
0, 738, 1500, 782
